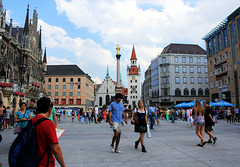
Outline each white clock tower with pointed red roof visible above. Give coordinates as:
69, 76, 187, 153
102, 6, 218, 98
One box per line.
127, 46, 141, 108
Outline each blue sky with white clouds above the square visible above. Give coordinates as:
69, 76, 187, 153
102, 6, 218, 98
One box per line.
2, 0, 240, 86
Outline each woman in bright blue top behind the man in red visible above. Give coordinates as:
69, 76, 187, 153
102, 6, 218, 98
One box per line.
15, 102, 31, 133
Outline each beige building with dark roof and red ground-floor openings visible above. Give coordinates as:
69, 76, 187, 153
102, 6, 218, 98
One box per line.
45, 65, 94, 107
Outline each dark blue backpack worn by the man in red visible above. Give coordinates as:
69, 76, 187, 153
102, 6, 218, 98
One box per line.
8, 118, 50, 167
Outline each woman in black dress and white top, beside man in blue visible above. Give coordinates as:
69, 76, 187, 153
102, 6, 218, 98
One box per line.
131, 100, 148, 152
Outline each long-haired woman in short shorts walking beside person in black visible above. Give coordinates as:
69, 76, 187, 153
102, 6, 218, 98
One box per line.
191, 100, 206, 147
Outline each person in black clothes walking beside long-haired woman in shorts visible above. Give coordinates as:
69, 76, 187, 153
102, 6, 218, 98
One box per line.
205, 101, 217, 144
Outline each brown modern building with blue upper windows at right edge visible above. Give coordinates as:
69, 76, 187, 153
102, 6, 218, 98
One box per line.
203, 7, 240, 106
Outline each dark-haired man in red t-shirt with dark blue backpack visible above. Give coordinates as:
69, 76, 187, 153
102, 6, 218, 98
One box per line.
9, 97, 65, 167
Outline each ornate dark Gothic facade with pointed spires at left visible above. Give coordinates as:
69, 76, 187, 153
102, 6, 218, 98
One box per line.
0, 0, 47, 109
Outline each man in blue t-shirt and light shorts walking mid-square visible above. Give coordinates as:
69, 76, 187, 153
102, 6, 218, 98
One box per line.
109, 93, 128, 153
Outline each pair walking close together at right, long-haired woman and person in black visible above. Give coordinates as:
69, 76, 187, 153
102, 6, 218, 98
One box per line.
191, 100, 217, 147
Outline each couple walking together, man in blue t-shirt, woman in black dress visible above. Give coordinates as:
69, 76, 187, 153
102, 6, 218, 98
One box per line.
109, 93, 147, 153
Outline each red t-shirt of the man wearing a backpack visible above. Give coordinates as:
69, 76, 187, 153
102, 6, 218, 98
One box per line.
32, 115, 58, 167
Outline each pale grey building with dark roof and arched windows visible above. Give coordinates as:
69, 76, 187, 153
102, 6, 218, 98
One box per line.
157, 44, 209, 106
